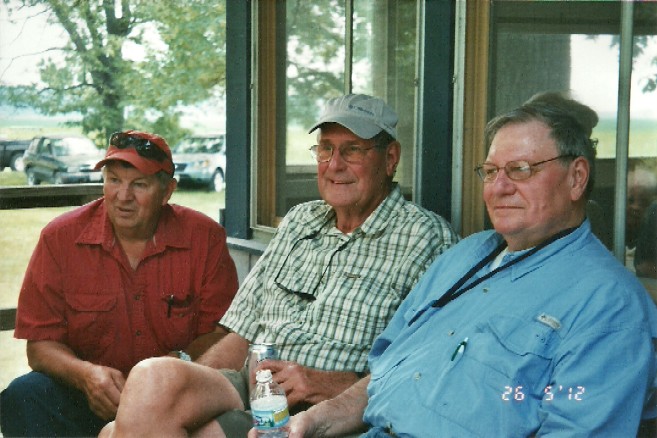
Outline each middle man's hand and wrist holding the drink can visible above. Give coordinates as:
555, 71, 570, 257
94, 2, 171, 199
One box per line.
257, 360, 358, 406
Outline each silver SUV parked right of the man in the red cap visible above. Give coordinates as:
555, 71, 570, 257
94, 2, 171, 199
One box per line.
172, 134, 226, 192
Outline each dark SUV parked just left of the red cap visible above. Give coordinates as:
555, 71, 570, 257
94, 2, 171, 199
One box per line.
23, 136, 104, 186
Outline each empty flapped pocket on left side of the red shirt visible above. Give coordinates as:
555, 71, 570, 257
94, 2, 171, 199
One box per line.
66, 294, 117, 359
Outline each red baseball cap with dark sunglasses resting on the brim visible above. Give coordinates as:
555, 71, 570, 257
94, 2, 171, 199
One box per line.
95, 130, 174, 176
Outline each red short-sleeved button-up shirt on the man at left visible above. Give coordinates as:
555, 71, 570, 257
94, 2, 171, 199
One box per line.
14, 199, 237, 374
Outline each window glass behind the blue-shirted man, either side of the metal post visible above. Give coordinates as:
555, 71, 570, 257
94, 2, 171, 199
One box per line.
489, 1, 657, 297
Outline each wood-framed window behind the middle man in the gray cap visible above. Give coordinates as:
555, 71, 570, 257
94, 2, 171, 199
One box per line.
253, 0, 418, 228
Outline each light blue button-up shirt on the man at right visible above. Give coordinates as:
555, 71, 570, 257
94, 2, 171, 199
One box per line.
364, 221, 657, 437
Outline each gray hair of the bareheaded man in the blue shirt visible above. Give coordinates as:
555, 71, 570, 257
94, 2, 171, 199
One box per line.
484, 92, 598, 198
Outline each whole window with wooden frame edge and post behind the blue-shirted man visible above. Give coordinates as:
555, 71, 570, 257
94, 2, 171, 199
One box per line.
464, 0, 657, 296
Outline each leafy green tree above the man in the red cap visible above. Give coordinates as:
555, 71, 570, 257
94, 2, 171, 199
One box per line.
3, 0, 225, 143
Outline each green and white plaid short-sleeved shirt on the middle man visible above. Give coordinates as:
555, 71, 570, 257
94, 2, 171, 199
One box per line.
220, 186, 458, 372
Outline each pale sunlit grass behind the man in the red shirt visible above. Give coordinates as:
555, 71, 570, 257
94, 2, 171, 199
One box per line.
0, 171, 225, 308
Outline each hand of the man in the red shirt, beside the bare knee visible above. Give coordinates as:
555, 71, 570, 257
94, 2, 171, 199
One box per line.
80, 363, 125, 420
